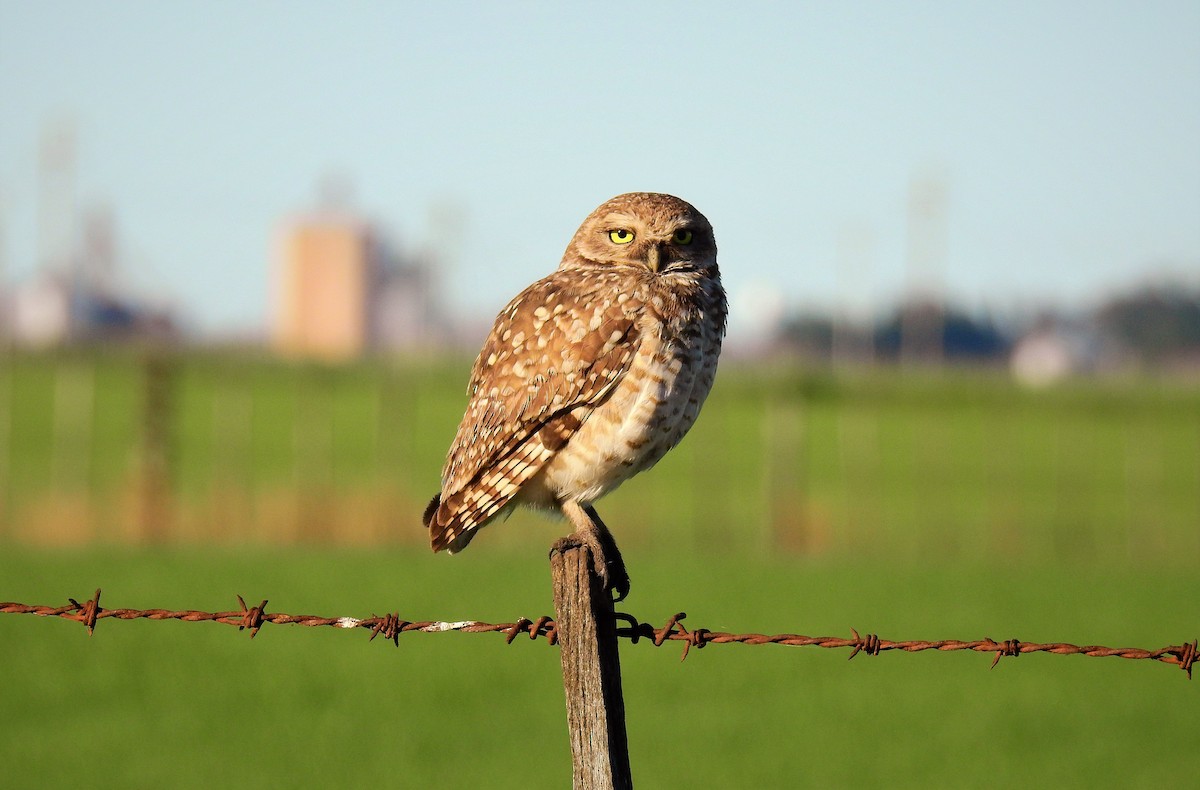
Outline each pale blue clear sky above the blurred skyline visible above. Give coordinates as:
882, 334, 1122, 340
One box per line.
0, 0, 1200, 331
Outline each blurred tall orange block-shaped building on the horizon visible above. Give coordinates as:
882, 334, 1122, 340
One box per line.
271, 216, 378, 360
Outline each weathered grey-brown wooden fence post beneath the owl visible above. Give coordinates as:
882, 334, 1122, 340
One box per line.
550, 538, 634, 790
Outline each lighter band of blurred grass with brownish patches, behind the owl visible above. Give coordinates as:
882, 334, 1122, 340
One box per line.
0, 354, 1200, 565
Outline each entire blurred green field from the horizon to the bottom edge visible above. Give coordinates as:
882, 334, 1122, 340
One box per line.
0, 354, 1200, 788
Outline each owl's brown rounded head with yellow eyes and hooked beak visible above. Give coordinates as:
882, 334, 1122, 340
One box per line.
559, 192, 716, 274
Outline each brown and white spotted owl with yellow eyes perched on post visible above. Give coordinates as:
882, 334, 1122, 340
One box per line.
424, 192, 726, 600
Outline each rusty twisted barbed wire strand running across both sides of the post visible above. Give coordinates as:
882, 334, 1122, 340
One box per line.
0, 589, 1200, 680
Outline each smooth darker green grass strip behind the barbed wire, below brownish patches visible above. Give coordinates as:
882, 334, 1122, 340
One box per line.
0, 546, 1200, 788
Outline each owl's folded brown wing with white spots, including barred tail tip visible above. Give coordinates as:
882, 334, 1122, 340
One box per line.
424, 270, 637, 551
